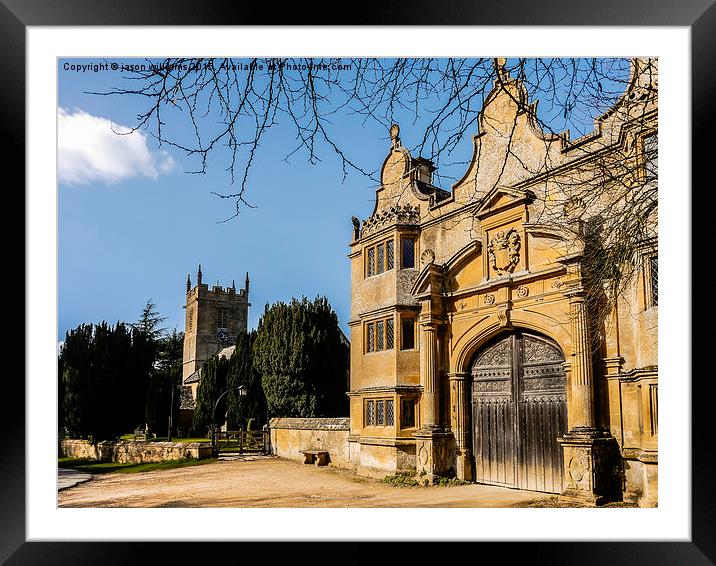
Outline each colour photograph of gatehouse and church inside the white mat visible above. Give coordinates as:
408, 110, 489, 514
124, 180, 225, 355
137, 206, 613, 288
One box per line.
56, 53, 656, 520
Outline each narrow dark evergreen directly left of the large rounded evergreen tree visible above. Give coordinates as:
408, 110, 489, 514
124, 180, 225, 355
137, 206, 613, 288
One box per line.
226, 330, 266, 430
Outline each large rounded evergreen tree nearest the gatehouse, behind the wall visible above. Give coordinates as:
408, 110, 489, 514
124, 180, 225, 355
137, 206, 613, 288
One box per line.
253, 297, 348, 417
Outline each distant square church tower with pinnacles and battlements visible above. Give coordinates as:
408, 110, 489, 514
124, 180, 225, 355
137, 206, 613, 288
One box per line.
182, 265, 251, 399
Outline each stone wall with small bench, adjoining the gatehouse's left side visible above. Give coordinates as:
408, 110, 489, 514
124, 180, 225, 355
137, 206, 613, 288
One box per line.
269, 417, 354, 469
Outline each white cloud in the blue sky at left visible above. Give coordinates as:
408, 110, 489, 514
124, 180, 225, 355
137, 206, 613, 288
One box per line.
57, 108, 176, 185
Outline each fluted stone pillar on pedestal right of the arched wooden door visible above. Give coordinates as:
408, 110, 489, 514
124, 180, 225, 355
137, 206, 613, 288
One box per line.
558, 285, 613, 505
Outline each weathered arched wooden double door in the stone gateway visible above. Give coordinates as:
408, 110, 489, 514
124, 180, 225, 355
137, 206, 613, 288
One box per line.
472, 332, 567, 493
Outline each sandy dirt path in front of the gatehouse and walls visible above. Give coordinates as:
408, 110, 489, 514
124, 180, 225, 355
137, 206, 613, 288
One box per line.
57, 457, 545, 507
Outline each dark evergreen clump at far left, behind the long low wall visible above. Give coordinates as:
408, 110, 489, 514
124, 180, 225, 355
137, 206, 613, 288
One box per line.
58, 300, 171, 440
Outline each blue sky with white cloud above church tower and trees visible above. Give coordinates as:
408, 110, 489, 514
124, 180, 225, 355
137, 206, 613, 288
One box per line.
58, 59, 628, 340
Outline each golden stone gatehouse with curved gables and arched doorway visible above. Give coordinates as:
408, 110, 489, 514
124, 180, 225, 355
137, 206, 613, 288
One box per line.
348, 59, 658, 506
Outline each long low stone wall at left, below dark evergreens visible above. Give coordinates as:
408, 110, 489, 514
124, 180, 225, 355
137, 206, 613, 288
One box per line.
59, 440, 211, 464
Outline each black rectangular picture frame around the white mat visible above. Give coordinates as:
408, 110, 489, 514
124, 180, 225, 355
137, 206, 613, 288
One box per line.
0, 0, 700, 566
